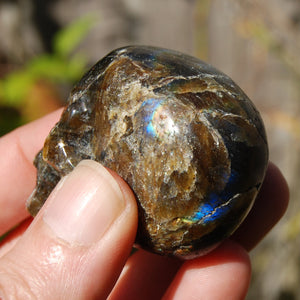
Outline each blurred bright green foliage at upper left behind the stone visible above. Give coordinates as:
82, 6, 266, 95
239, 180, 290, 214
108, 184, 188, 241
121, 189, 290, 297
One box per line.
0, 16, 95, 136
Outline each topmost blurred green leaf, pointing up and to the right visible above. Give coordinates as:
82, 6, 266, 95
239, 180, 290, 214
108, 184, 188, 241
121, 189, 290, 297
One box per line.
53, 15, 95, 57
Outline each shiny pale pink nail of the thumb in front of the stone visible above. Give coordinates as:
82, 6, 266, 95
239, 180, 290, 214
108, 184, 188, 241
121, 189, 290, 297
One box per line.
43, 160, 125, 245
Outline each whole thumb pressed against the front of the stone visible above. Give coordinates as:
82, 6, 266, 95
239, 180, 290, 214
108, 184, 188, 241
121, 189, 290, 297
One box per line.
0, 161, 137, 299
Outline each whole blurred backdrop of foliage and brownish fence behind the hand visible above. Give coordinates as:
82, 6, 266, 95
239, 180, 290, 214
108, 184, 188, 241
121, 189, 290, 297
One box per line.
0, 0, 300, 300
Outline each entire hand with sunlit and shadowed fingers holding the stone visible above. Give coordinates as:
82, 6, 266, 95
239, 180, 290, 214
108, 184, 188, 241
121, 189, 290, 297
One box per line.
0, 111, 288, 300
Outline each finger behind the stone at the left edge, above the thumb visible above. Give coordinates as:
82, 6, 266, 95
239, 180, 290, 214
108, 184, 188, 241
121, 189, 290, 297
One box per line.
0, 109, 62, 235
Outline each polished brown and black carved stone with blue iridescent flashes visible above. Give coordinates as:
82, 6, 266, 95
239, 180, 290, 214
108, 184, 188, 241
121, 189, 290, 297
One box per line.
27, 46, 268, 258
